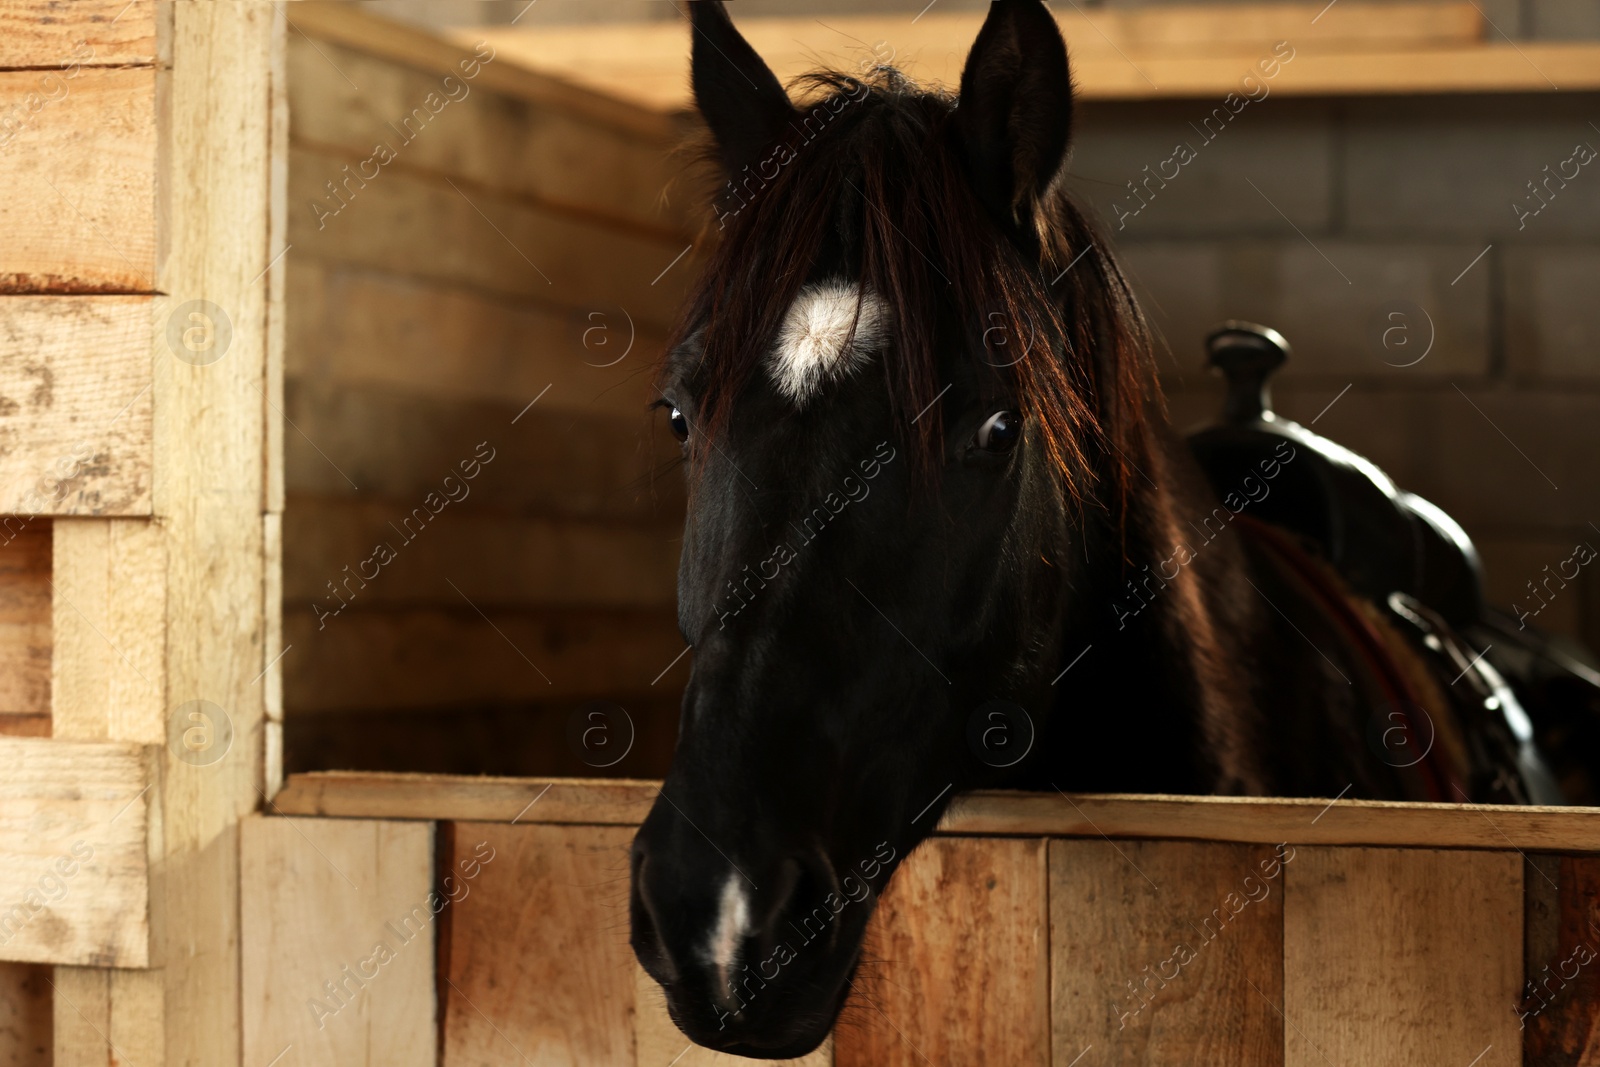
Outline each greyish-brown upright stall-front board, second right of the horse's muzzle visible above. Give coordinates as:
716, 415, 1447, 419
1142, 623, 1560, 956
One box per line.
1050, 838, 1294, 1067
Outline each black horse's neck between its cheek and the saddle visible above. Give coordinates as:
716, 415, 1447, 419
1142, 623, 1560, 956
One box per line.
1056, 427, 1264, 792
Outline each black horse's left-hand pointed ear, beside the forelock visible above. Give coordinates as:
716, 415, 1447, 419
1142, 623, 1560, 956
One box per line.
690, 0, 795, 174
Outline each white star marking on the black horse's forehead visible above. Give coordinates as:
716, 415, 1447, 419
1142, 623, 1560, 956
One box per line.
768, 282, 890, 405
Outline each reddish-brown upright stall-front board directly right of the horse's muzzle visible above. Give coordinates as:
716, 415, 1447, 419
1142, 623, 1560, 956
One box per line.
834, 838, 1050, 1067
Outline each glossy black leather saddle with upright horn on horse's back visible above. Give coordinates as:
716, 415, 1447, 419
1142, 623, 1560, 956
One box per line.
1189, 322, 1485, 629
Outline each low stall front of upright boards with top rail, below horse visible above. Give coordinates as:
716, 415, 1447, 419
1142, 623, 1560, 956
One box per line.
243, 774, 1600, 1067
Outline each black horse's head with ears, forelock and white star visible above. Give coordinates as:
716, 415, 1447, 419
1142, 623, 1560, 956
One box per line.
632, 0, 1144, 1059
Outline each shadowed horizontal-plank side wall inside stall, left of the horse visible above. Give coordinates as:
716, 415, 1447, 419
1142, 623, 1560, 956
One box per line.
283, 5, 698, 773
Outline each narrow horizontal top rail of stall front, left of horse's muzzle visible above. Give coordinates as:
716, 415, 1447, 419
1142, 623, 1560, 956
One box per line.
274, 771, 661, 827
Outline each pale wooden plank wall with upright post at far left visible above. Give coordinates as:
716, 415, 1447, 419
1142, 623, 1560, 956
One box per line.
0, 0, 286, 1067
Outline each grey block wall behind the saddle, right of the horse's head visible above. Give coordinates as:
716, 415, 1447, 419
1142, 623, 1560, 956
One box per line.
1069, 93, 1600, 648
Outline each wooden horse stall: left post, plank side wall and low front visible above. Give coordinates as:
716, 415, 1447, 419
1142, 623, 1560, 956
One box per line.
0, 0, 1600, 1067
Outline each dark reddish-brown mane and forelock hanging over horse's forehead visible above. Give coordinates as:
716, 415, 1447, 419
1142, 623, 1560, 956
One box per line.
672, 67, 1160, 514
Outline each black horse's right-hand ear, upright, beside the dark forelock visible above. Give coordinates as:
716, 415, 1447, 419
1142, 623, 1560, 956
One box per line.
955, 0, 1072, 232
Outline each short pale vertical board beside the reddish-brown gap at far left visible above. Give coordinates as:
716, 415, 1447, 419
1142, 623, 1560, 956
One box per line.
51, 518, 168, 745
